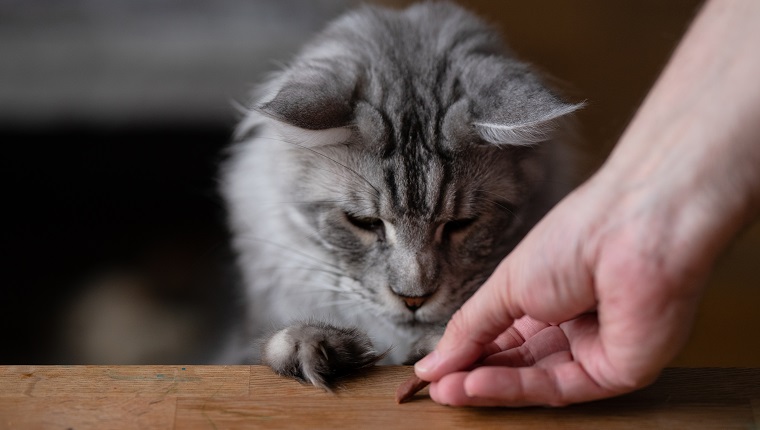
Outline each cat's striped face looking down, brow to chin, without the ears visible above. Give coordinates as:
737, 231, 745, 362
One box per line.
293, 116, 541, 324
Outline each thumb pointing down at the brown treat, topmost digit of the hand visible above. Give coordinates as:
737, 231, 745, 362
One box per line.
414, 258, 523, 381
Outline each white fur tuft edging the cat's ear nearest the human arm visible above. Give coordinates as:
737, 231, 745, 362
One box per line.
473, 103, 585, 146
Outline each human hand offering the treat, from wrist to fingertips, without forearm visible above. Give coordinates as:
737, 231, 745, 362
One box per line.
415, 178, 712, 406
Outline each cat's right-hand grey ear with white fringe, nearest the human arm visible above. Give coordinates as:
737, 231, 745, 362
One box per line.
464, 57, 583, 146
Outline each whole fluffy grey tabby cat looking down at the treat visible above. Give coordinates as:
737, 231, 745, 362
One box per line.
223, 3, 579, 389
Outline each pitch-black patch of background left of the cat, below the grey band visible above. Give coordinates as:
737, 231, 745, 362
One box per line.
0, 124, 230, 363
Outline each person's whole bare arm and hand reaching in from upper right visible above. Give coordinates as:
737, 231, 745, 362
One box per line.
415, 0, 760, 406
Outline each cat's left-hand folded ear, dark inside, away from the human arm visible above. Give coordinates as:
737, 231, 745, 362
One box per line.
257, 60, 357, 130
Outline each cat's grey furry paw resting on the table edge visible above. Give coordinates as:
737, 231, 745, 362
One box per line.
261, 322, 385, 391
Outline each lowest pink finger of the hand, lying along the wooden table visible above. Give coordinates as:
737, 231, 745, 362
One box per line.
460, 362, 621, 406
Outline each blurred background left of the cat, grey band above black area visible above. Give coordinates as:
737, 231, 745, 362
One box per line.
0, 0, 357, 363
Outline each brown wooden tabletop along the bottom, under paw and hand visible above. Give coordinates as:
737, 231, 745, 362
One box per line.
0, 366, 760, 430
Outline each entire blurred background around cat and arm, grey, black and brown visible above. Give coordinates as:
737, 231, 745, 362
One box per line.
0, 0, 760, 366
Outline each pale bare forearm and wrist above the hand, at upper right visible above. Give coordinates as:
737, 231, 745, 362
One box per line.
598, 0, 760, 255
